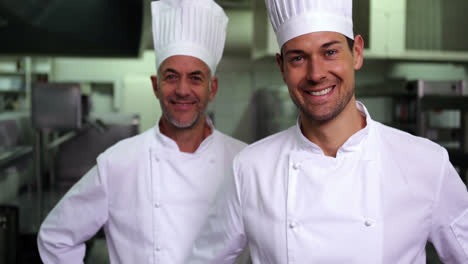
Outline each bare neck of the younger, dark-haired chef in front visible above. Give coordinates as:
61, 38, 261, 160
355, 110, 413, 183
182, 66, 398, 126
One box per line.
301, 97, 366, 157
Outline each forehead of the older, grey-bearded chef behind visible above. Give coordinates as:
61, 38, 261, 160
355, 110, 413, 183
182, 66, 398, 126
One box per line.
159, 55, 210, 74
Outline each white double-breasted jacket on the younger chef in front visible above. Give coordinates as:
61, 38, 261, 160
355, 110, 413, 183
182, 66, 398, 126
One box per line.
188, 103, 468, 264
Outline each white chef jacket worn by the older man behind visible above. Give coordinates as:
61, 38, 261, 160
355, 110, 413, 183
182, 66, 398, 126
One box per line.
38, 122, 245, 264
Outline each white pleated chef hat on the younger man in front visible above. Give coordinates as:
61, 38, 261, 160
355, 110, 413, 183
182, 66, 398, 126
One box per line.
265, 0, 354, 48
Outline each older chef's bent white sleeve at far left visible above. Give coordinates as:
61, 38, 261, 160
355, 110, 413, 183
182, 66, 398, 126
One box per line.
37, 166, 108, 264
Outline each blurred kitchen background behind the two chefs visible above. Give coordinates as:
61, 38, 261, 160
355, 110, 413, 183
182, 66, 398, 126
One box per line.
0, 0, 468, 263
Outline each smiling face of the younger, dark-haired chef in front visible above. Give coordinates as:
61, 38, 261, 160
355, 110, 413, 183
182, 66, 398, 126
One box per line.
277, 31, 363, 121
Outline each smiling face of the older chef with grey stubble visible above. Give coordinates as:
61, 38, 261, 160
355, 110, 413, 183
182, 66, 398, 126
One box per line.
152, 55, 218, 128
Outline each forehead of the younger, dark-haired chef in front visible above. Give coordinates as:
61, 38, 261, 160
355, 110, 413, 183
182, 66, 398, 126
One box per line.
282, 31, 347, 53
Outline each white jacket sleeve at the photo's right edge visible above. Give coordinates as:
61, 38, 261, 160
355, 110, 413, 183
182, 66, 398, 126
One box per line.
429, 151, 468, 263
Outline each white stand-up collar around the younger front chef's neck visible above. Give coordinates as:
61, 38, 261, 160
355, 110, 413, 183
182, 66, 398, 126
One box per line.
295, 101, 374, 157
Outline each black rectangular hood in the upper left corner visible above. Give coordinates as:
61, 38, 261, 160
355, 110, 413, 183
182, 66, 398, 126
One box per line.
0, 0, 143, 57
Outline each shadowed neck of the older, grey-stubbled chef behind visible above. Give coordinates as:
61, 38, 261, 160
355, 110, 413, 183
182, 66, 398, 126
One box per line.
159, 116, 212, 153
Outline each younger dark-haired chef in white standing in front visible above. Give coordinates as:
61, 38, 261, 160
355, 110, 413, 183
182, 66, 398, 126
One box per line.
188, 0, 468, 264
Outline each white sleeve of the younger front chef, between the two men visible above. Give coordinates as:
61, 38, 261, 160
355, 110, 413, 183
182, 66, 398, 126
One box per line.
187, 156, 250, 264
